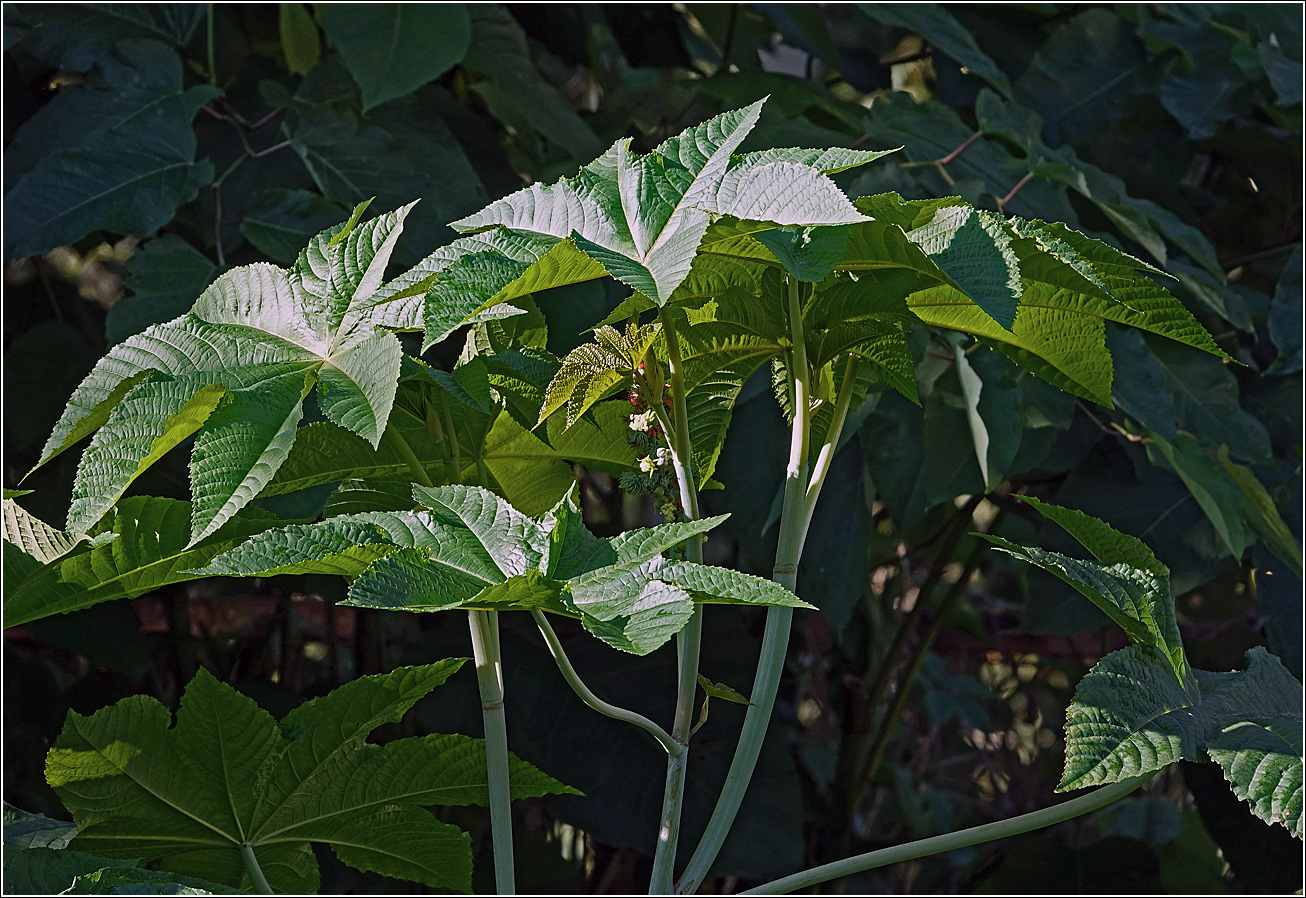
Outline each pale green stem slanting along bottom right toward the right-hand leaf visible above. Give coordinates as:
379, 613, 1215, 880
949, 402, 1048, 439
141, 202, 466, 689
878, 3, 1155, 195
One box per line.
741, 770, 1156, 895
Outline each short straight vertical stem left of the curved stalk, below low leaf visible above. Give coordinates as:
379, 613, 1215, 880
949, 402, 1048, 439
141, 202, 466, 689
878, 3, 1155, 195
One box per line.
468, 611, 516, 895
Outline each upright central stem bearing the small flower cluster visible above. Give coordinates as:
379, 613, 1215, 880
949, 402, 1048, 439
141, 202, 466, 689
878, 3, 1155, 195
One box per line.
649, 307, 703, 894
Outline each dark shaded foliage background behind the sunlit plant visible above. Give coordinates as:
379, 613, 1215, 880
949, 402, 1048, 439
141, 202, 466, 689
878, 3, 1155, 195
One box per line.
4, 4, 1302, 893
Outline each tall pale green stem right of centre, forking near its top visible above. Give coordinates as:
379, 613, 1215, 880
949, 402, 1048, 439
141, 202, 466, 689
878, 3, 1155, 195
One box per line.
677, 278, 820, 894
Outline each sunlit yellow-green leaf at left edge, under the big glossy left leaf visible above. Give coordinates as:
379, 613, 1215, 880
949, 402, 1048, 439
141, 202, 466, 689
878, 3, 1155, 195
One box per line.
4, 496, 285, 627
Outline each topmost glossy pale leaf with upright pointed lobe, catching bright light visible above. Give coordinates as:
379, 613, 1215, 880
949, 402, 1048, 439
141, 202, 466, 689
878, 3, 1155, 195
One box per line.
453, 101, 882, 305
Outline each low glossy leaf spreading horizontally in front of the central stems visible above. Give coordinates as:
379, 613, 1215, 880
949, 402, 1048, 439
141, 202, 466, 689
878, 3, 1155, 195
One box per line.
195, 486, 807, 654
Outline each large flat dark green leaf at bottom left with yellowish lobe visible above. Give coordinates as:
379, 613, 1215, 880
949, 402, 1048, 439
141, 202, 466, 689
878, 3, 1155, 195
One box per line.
46, 659, 573, 894
